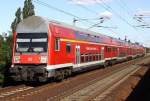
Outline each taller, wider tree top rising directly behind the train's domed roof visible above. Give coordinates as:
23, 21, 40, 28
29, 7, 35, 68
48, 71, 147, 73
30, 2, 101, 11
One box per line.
23, 0, 35, 19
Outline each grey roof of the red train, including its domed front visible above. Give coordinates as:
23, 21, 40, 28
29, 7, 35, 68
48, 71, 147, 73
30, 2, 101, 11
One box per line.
16, 16, 143, 46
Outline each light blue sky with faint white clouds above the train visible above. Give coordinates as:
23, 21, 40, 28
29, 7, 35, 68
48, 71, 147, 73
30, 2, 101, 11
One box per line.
0, 0, 150, 47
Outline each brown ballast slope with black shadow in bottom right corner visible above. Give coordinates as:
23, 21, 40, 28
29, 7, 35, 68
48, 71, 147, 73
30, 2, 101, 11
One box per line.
103, 62, 150, 101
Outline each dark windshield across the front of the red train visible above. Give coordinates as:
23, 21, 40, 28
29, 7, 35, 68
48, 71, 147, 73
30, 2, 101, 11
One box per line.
16, 33, 48, 54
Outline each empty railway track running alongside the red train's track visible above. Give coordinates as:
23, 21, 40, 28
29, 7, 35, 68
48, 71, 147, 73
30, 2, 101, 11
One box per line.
47, 55, 148, 101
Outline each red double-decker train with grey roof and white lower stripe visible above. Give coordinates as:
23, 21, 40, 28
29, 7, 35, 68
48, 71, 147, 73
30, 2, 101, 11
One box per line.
10, 16, 145, 82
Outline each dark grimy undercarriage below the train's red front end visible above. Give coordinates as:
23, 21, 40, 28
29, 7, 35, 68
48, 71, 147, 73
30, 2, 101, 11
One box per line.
9, 65, 48, 82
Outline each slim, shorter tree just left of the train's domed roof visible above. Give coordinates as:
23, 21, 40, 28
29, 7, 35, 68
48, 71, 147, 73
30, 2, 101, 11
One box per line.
11, 7, 21, 32
